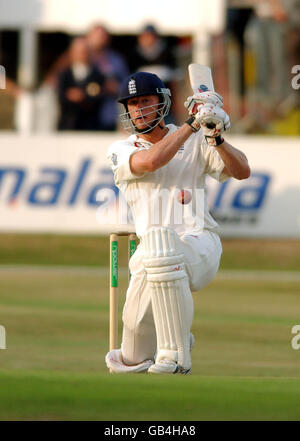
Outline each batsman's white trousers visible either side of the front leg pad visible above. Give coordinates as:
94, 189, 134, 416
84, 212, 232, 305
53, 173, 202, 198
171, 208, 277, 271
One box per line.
121, 231, 222, 365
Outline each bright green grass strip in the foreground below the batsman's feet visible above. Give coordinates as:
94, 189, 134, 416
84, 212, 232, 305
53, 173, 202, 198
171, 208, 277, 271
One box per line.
0, 371, 300, 421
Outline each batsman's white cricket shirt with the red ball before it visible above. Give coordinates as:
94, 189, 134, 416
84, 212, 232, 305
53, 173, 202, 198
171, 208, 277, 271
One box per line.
107, 124, 229, 237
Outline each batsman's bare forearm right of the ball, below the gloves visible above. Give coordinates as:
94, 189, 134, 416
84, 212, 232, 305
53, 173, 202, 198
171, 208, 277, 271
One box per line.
216, 141, 251, 179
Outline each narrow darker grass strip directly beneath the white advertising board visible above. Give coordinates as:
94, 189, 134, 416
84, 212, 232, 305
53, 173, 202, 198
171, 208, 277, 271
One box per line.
0, 234, 300, 271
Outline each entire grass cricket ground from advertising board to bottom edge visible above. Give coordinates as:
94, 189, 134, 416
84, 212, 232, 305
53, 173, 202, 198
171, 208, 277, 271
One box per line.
0, 236, 300, 421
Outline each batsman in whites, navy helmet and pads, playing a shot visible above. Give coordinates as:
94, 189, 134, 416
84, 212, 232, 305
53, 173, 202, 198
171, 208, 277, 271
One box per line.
106, 72, 250, 374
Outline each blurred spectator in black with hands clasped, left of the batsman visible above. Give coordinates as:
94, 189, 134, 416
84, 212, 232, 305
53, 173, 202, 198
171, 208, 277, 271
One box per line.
58, 37, 104, 130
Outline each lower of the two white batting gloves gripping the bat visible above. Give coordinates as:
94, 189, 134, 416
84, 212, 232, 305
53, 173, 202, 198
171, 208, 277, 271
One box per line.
186, 103, 230, 146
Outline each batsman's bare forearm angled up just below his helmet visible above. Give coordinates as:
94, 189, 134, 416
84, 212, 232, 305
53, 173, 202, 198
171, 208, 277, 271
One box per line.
148, 124, 193, 171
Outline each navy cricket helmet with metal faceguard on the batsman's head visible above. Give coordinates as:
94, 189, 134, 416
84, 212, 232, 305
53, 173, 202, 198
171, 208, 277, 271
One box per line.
118, 72, 171, 133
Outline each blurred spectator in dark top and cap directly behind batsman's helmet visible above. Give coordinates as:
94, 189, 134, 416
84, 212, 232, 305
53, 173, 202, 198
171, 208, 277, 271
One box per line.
129, 24, 182, 123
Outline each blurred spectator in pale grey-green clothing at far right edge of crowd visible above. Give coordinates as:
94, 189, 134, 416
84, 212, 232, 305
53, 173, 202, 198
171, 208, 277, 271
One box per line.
237, 0, 300, 133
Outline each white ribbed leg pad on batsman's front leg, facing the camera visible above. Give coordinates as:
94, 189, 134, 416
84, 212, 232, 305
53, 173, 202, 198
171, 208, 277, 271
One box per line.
142, 228, 193, 369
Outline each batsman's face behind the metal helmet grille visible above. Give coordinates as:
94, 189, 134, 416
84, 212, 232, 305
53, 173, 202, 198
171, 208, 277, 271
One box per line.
127, 95, 159, 129
